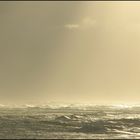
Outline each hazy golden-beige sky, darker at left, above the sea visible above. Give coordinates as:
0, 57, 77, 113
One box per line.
0, 1, 140, 104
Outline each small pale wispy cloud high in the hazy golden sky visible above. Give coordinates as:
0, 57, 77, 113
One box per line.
65, 17, 96, 29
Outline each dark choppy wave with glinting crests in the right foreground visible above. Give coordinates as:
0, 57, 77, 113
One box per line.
41, 114, 140, 134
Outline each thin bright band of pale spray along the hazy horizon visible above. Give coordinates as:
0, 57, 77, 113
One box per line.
0, 102, 140, 110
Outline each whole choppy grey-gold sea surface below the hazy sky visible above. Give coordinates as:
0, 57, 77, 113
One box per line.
0, 105, 140, 139
